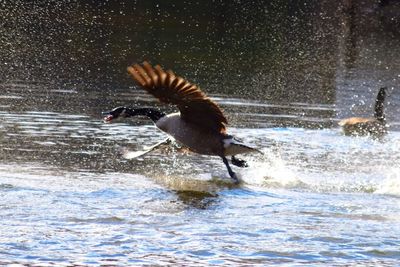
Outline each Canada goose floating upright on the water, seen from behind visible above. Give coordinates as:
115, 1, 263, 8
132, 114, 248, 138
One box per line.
339, 87, 387, 137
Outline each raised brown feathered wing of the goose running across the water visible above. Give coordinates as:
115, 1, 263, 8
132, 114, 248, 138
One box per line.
128, 61, 228, 133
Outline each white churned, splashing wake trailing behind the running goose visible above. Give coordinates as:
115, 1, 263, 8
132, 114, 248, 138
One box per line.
231, 129, 400, 195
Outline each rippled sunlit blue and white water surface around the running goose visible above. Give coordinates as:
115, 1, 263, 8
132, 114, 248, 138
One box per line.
0, 84, 400, 266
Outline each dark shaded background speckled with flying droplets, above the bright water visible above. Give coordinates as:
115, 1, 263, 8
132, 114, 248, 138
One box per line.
0, 0, 400, 121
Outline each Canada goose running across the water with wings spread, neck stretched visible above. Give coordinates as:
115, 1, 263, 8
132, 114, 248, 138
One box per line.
104, 61, 262, 183
